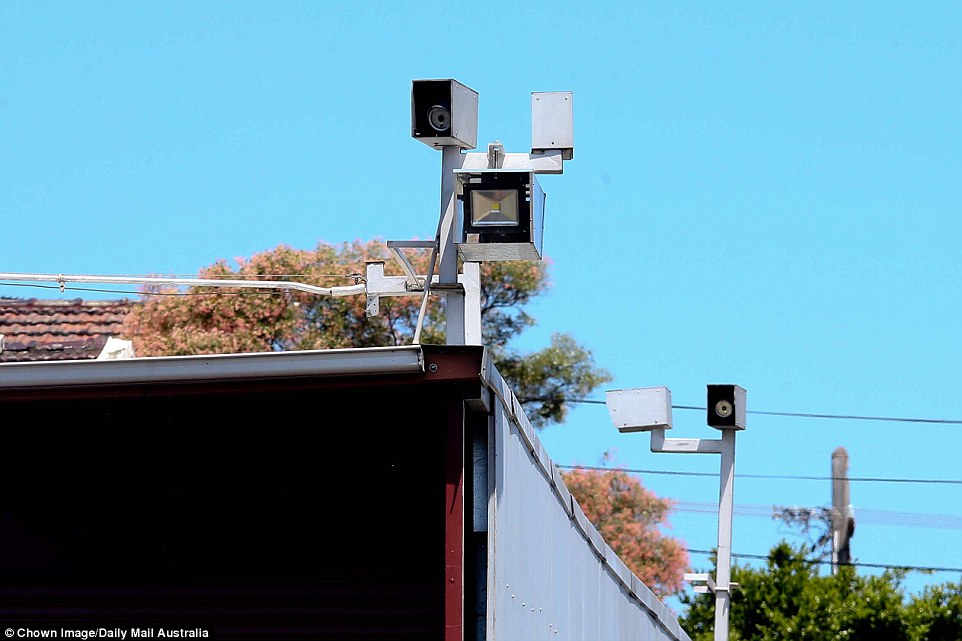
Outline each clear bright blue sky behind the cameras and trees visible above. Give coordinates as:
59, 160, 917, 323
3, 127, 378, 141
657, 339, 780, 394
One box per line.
0, 1, 962, 604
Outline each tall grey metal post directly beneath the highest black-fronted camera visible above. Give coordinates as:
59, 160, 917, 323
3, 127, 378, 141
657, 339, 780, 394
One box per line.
438, 145, 465, 345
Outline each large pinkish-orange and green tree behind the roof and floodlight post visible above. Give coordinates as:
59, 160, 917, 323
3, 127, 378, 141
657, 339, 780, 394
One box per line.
125, 241, 610, 427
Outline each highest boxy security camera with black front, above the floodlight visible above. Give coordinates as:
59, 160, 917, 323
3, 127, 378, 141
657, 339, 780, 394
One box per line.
411, 79, 478, 149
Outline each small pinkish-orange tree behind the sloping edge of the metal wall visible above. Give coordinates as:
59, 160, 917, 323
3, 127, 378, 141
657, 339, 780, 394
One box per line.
562, 460, 688, 597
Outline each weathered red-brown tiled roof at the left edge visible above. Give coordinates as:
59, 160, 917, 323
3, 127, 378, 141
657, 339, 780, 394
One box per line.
0, 298, 131, 363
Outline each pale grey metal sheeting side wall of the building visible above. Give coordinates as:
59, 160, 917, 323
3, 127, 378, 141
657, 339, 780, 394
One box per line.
486, 368, 689, 641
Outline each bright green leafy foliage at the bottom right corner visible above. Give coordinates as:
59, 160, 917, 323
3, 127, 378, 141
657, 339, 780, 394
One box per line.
681, 542, 962, 641
